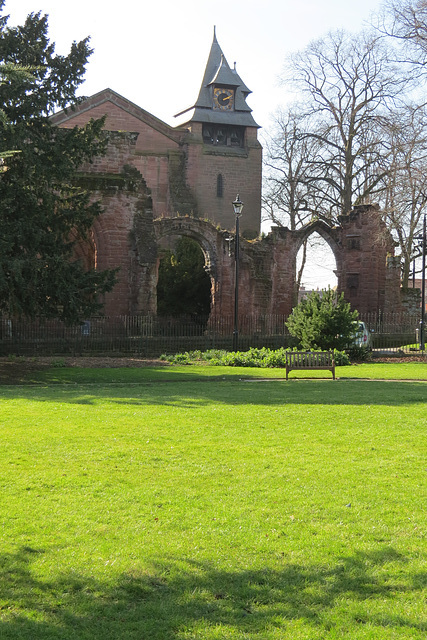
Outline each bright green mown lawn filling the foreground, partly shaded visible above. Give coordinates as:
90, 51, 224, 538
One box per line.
0, 364, 427, 640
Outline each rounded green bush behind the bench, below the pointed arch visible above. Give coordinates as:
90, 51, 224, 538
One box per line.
286, 289, 358, 350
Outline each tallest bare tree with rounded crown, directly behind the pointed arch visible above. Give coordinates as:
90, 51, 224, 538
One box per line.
280, 31, 407, 217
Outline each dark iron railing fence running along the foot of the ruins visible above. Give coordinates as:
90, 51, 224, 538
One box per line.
0, 313, 419, 357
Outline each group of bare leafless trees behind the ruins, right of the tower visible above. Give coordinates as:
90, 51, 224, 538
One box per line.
265, 26, 427, 292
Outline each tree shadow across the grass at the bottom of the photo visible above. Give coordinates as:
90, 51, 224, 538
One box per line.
0, 547, 427, 640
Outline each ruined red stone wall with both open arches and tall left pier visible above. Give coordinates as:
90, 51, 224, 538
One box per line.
74, 146, 401, 316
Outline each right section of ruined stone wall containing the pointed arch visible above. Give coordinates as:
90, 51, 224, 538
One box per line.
251, 206, 401, 315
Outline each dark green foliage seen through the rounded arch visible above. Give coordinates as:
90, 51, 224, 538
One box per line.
157, 237, 211, 316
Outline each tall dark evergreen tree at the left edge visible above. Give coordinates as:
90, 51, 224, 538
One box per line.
0, 1, 115, 322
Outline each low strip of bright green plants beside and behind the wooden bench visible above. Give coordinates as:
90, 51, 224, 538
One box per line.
161, 347, 350, 368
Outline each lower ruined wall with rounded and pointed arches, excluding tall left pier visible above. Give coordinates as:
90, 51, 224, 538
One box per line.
151, 206, 402, 315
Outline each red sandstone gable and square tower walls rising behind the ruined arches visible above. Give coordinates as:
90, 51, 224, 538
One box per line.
53, 89, 262, 237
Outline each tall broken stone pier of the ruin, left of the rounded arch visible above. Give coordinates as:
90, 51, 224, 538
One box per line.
77, 132, 157, 315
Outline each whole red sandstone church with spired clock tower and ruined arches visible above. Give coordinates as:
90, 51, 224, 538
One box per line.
53, 30, 400, 316
